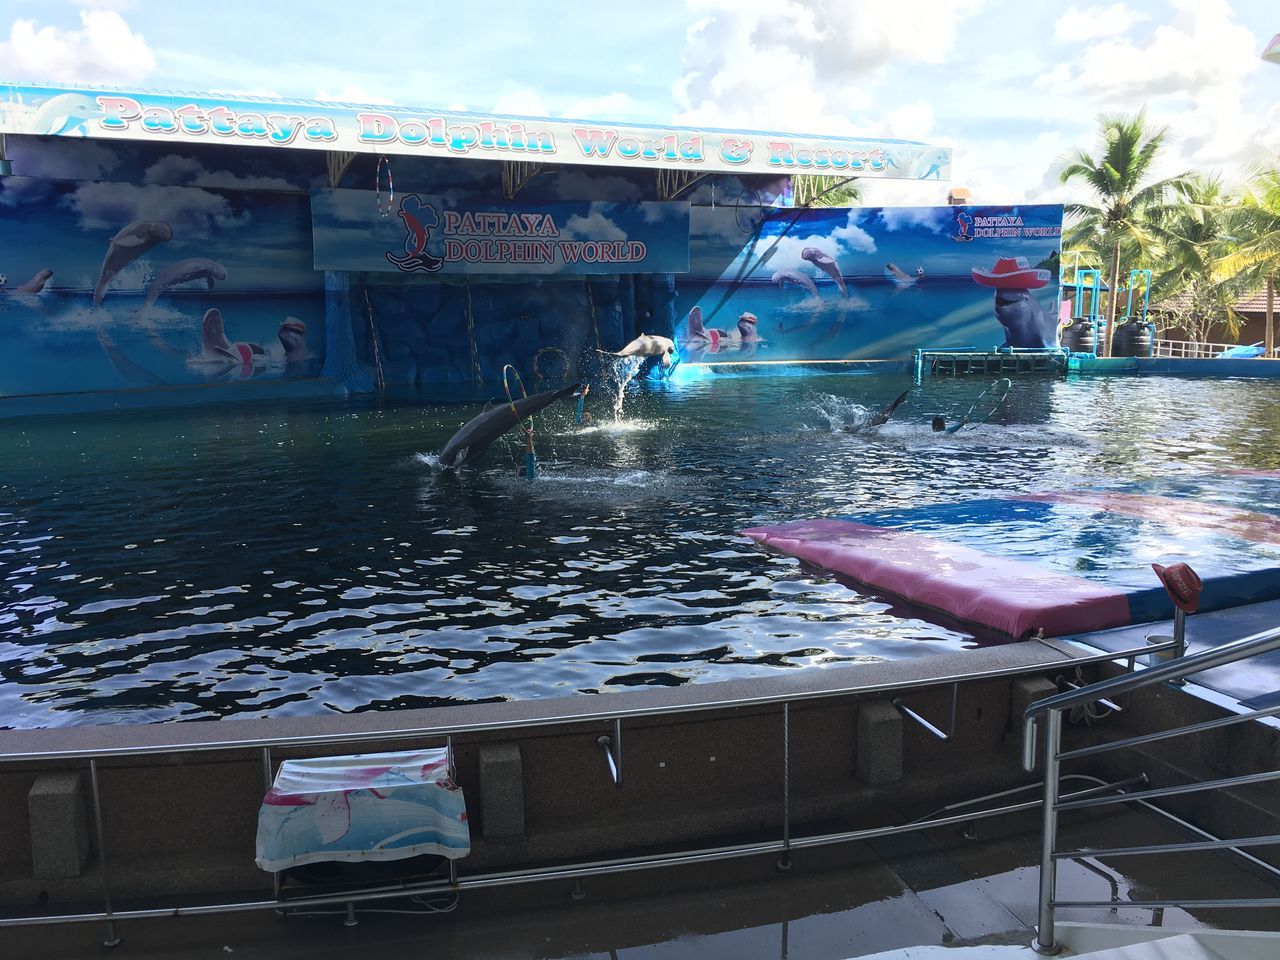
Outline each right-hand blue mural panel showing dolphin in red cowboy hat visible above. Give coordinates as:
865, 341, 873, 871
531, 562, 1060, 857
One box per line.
676, 205, 1062, 362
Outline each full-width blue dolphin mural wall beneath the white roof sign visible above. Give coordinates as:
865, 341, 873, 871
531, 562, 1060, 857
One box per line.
0, 137, 1062, 404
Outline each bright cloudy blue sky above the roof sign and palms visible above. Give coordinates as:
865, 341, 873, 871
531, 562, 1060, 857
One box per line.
0, 0, 1280, 204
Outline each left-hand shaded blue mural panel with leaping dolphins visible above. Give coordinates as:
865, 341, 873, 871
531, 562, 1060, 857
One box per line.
0, 170, 325, 396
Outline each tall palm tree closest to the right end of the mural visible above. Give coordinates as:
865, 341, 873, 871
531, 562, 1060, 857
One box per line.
1061, 110, 1187, 356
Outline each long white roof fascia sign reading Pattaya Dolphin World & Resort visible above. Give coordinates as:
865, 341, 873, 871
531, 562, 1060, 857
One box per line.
0, 83, 951, 180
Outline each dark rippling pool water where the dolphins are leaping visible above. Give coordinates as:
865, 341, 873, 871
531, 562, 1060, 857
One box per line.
0, 375, 1280, 727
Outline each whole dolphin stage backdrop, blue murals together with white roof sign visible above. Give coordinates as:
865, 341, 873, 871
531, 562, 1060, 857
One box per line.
0, 84, 1062, 411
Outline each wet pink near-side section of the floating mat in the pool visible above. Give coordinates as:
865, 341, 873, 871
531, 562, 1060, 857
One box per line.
742, 520, 1132, 637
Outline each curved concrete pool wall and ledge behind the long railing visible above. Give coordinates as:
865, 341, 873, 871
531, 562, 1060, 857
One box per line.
0, 641, 1276, 942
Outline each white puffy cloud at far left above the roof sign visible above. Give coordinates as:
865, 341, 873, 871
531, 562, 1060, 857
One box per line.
0, 10, 156, 83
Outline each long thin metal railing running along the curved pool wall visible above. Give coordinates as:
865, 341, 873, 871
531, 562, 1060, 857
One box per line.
0, 640, 1175, 946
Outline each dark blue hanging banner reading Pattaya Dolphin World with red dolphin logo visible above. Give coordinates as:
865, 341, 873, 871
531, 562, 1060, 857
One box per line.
311, 189, 689, 276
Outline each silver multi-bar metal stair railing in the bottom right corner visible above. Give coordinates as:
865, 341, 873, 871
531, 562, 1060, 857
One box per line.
1023, 628, 1280, 955
